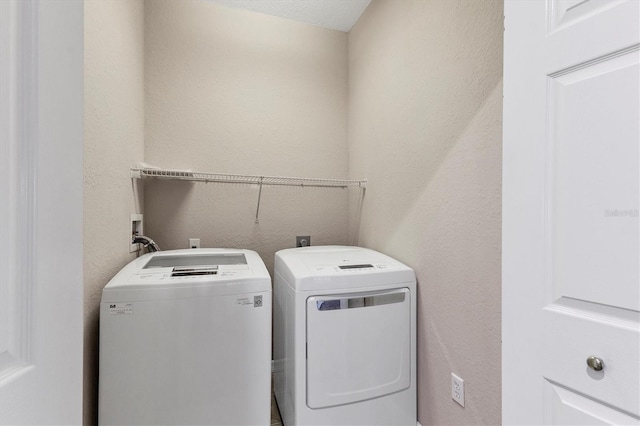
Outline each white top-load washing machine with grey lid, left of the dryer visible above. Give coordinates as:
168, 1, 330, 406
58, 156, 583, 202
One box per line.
98, 249, 272, 425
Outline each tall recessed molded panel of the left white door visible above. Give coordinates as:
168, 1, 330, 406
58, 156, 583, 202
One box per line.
0, 0, 38, 386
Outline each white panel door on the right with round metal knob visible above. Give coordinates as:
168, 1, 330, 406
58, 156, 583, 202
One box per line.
503, 0, 640, 425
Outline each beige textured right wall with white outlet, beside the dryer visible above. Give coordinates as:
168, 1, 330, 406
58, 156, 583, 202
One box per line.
349, 0, 503, 425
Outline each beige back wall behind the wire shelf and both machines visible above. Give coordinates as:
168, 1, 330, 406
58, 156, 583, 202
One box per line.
145, 0, 349, 272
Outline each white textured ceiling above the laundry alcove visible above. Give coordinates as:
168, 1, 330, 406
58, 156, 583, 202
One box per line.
210, 0, 371, 32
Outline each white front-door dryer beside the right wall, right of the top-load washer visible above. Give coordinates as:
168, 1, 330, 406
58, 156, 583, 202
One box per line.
274, 246, 417, 426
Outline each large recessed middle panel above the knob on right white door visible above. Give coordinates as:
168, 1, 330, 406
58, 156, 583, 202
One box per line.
545, 44, 640, 310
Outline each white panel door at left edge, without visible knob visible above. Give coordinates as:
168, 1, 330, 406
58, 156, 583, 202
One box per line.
0, 0, 83, 425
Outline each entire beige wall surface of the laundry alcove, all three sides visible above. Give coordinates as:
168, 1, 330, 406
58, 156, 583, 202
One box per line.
84, 0, 503, 426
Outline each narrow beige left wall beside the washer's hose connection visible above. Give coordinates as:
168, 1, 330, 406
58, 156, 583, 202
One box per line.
84, 0, 144, 424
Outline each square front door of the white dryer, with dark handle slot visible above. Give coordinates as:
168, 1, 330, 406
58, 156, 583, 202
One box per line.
307, 288, 411, 408
